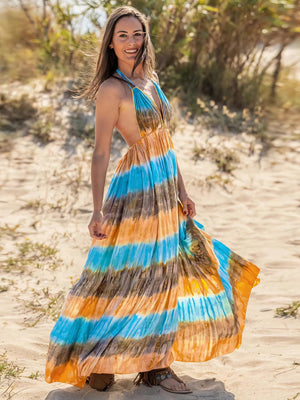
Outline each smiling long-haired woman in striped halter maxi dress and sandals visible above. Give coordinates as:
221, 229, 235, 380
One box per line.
45, 7, 259, 393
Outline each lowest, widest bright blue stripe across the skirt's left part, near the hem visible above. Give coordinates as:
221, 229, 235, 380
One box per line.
50, 308, 178, 345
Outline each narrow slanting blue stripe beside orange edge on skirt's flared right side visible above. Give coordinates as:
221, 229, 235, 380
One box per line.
212, 238, 233, 303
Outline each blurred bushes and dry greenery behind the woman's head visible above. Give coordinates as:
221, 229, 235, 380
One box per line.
0, 0, 300, 140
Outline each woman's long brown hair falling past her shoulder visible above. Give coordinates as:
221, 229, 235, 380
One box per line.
75, 6, 155, 103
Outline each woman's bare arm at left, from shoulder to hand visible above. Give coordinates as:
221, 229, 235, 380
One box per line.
88, 81, 120, 239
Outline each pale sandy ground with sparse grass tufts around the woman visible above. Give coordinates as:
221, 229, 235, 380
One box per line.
0, 79, 300, 400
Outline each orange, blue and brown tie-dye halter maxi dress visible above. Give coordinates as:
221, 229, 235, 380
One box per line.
45, 69, 260, 388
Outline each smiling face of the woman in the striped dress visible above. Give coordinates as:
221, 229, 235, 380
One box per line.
109, 16, 144, 64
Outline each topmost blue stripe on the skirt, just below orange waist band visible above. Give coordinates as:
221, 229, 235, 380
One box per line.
106, 149, 177, 199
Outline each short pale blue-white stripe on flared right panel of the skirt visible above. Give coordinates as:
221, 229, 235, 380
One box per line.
177, 291, 233, 322
